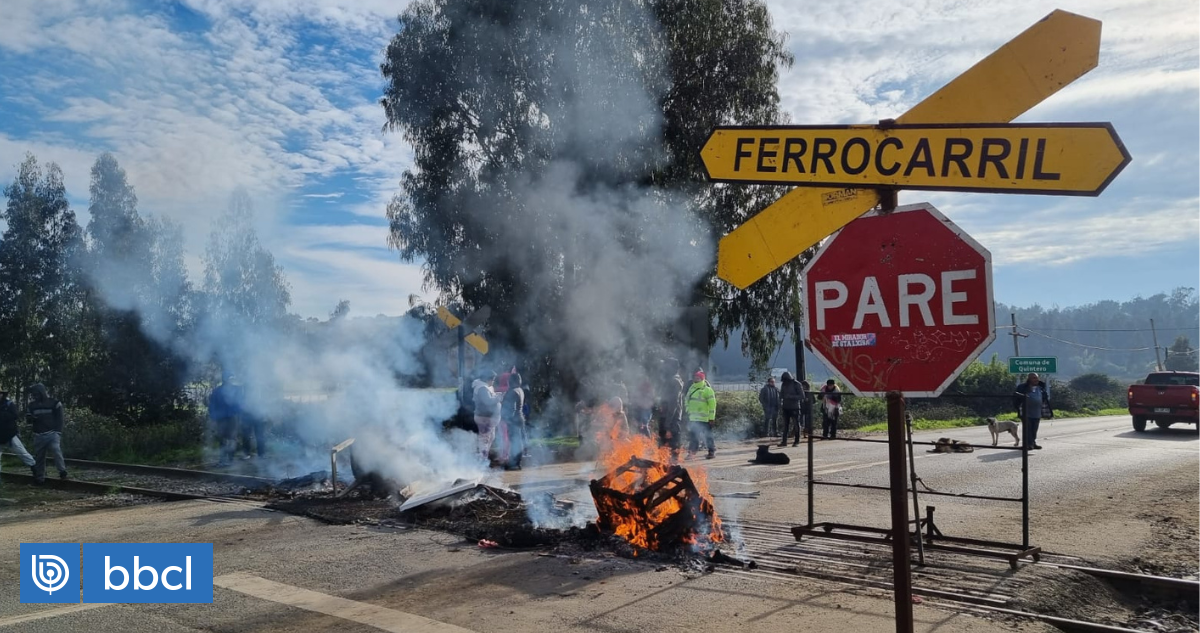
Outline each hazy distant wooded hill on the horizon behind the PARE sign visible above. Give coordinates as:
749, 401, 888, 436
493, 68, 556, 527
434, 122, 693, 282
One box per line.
709, 288, 1200, 381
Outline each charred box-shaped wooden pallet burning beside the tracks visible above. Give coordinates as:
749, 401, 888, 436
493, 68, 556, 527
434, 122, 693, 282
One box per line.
590, 457, 724, 550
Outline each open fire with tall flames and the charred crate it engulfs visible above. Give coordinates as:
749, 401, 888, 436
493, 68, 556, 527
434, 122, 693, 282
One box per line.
590, 410, 725, 553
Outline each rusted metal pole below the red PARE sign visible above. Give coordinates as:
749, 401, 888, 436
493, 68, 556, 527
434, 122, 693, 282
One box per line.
888, 391, 912, 633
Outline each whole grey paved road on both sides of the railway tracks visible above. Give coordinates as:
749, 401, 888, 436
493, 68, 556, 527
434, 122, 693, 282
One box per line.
0, 417, 1198, 633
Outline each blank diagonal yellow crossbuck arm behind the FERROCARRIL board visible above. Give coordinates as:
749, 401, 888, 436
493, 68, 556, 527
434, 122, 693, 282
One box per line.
716, 11, 1100, 288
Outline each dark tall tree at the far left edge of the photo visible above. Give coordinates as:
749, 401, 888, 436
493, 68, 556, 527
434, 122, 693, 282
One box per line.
0, 155, 83, 397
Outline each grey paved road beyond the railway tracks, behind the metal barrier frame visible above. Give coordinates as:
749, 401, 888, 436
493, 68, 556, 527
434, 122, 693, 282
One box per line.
506, 416, 1200, 559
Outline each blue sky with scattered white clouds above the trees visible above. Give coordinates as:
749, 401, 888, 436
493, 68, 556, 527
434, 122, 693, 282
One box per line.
0, 0, 1200, 317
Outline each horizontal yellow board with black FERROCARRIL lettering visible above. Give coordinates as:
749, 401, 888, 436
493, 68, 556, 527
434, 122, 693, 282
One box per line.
701, 123, 1129, 195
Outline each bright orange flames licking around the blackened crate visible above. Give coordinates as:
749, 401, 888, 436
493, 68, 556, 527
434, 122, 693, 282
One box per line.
595, 405, 725, 549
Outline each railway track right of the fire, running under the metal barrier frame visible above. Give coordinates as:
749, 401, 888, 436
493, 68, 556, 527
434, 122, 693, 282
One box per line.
726, 522, 1200, 633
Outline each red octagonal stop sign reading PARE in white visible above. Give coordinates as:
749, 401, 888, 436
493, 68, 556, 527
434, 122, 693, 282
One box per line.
803, 204, 996, 398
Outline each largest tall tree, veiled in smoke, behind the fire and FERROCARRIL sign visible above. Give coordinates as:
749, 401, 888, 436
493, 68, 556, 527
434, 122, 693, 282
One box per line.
382, 0, 796, 390
